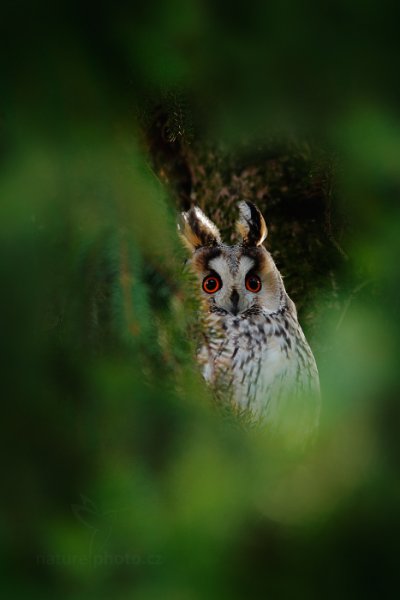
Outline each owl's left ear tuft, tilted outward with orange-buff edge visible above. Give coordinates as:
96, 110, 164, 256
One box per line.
178, 206, 222, 252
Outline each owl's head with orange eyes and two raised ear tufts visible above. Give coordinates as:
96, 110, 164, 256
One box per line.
180, 201, 286, 316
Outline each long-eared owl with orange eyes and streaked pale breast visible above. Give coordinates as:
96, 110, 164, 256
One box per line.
180, 201, 320, 439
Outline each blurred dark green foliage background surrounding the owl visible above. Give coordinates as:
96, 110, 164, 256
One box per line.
0, 0, 400, 600
